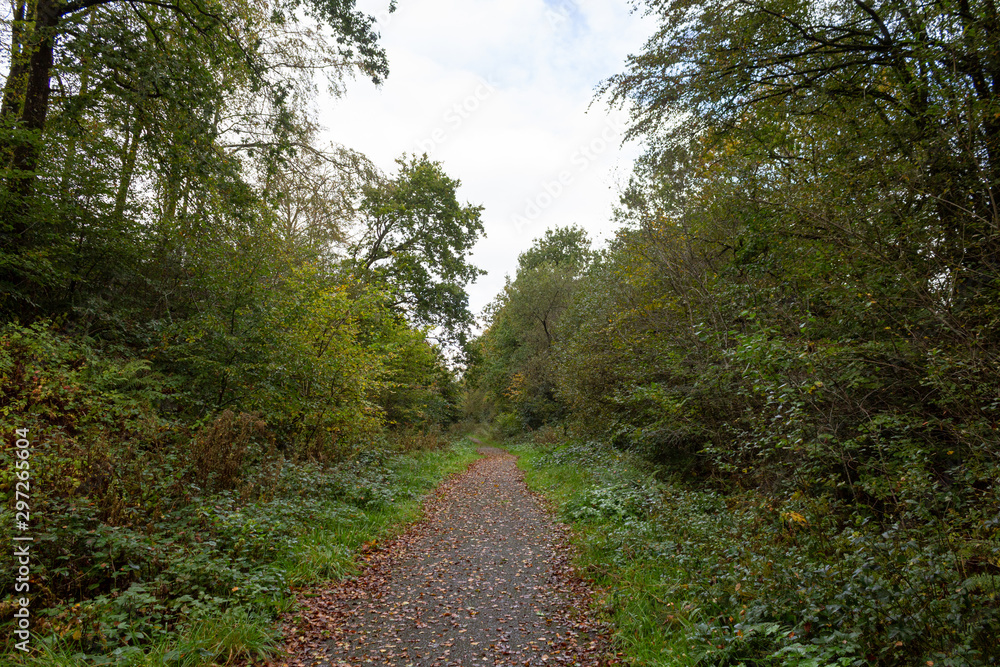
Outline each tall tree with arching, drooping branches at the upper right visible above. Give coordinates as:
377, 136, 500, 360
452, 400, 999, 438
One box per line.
604, 0, 1000, 324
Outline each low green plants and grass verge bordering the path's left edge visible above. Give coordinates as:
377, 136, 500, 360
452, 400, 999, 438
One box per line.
0, 444, 475, 666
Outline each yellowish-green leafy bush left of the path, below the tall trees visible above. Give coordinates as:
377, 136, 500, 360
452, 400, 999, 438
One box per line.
162, 264, 392, 458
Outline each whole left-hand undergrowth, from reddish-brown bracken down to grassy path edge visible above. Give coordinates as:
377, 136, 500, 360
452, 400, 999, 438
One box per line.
0, 320, 476, 667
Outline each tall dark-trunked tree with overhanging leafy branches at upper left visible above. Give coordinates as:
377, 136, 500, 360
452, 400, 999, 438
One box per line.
0, 0, 387, 316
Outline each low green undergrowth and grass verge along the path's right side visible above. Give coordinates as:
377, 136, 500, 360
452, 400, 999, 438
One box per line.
511, 442, 1000, 667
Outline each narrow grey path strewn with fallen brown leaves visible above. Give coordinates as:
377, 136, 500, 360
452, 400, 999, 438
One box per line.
284, 447, 606, 667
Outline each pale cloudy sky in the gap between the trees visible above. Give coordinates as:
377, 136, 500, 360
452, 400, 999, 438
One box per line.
321, 0, 651, 324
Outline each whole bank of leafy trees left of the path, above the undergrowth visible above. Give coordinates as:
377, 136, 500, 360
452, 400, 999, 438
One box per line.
0, 0, 458, 459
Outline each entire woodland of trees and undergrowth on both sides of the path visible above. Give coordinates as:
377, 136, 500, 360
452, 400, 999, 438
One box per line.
0, 0, 1000, 667
